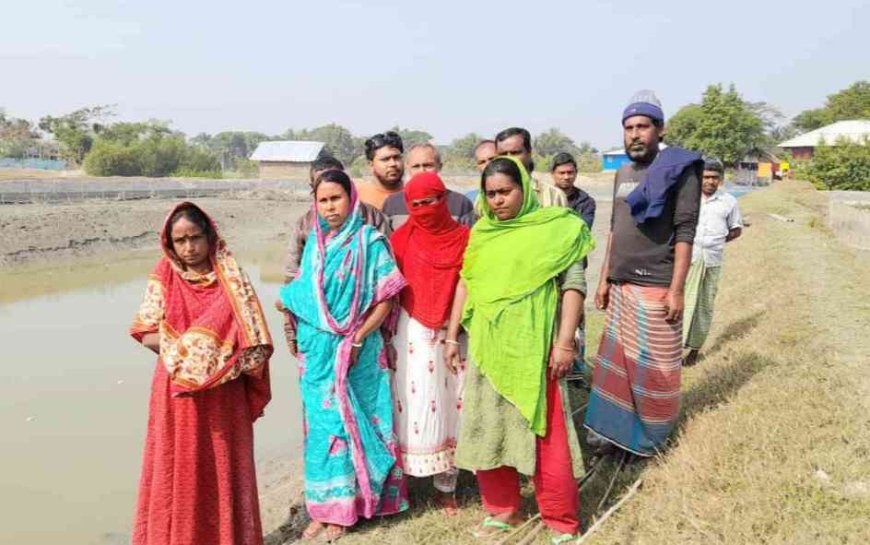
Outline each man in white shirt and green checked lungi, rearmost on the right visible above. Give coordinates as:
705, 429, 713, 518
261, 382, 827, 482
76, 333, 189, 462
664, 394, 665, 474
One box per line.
683, 158, 743, 366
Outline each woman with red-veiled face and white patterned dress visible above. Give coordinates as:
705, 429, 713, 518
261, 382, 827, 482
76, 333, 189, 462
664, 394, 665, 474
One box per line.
390, 172, 469, 515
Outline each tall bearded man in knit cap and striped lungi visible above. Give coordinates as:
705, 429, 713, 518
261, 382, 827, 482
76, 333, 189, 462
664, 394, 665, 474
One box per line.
585, 91, 703, 457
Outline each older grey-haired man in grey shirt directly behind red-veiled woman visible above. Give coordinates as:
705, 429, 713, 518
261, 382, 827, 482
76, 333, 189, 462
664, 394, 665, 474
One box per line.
383, 143, 477, 231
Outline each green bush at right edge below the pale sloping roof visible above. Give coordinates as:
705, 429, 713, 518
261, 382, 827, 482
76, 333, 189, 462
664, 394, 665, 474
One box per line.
800, 138, 870, 191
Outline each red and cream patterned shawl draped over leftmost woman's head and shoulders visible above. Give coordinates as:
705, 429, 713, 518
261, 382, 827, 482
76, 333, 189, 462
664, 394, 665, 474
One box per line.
130, 202, 272, 419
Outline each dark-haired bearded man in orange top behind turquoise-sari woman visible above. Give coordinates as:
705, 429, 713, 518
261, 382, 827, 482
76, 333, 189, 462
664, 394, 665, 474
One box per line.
356, 131, 405, 210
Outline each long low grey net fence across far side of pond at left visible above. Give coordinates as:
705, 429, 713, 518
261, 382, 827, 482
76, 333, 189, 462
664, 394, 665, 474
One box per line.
0, 178, 309, 204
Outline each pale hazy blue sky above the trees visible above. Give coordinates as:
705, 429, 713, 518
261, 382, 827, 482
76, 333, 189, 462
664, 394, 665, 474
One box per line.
0, 0, 870, 149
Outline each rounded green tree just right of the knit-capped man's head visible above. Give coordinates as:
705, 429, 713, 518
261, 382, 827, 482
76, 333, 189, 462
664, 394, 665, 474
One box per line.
665, 84, 766, 165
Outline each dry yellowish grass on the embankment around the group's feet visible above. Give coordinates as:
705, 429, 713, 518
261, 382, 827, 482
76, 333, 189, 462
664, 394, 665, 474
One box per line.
266, 183, 870, 545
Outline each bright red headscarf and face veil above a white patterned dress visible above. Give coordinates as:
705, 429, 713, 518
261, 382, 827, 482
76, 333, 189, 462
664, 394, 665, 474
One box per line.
390, 172, 469, 329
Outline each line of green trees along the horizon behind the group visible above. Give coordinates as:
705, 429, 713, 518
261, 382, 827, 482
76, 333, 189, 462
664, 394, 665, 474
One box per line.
0, 80, 870, 186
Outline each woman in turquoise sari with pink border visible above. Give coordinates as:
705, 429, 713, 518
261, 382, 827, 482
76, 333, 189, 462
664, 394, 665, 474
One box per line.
281, 170, 407, 539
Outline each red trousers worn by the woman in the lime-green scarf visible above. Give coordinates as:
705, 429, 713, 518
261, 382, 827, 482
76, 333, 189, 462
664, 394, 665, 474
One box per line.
476, 379, 580, 534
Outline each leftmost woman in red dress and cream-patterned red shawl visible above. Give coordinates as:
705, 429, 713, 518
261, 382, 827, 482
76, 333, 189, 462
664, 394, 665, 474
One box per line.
130, 202, 272, 545
